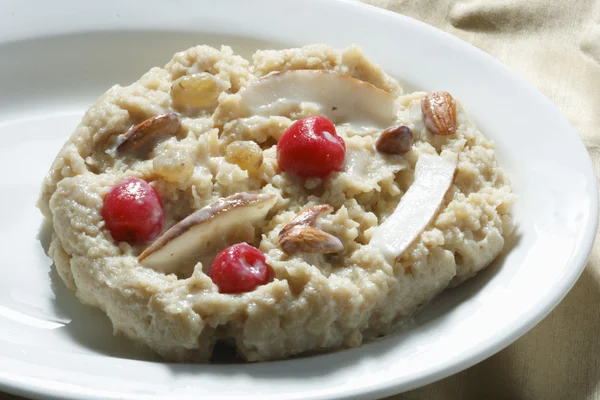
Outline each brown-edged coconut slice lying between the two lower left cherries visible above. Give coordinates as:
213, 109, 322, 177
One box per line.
138, 193, 277, 274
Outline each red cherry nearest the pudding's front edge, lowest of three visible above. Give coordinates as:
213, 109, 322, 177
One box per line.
209, 243, 272, 293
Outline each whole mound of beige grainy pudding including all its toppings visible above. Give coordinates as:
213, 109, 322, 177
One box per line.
38, 45, 515, 362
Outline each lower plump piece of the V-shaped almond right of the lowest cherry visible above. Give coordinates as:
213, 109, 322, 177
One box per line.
279, 226, 344, 254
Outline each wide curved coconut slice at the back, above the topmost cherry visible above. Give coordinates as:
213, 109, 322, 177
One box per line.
234, 70, 398, 129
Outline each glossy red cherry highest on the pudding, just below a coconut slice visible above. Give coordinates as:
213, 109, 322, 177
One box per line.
277, 116, 346, 178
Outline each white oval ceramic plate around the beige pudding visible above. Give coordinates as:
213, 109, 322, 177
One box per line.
0, 0, 598, 400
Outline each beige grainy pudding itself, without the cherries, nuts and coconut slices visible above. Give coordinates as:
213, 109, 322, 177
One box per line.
39, 45, 515, 361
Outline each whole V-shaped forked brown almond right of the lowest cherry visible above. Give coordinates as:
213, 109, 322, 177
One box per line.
279, 204, 344, 254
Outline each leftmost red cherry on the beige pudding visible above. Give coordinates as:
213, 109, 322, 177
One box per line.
102, 178, 165, 244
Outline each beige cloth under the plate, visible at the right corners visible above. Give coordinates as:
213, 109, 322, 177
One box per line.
354, 0, 600, 400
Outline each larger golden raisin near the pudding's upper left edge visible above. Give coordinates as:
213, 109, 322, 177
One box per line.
171, 72, 225, 108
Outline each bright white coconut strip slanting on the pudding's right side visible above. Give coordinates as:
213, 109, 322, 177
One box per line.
370, 154, 457, 264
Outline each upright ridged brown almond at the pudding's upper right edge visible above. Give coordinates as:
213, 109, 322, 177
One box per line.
421, 92, 457, 136
